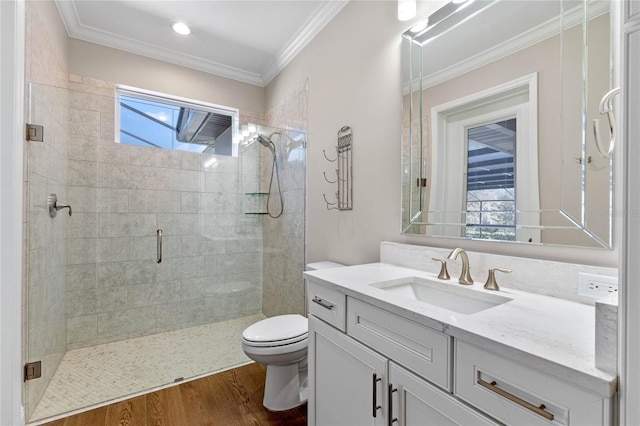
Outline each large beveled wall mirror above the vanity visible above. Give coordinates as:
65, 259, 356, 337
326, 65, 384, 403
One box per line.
402, 0, 615, 249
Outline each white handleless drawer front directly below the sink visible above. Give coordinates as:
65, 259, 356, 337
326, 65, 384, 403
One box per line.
347, 297, 452, 391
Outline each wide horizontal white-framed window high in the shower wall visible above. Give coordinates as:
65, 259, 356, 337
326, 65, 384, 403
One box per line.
116, 87, 238, 156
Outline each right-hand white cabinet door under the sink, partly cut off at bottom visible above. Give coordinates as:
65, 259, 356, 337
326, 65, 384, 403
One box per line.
389, 362, 497, 426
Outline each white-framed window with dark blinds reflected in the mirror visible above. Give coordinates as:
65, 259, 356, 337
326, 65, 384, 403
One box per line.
429, 73, 540, 242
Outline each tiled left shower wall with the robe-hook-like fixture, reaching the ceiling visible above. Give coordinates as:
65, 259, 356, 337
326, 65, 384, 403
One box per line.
23, 2, 69, 418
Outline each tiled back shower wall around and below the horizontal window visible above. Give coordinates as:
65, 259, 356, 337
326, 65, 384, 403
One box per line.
66, 76, 262, 349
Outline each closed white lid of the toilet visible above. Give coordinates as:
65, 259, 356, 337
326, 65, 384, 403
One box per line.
242, 314, 309, 342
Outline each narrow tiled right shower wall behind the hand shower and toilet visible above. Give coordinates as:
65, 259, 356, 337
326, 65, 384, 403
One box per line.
262, 83, 308, 316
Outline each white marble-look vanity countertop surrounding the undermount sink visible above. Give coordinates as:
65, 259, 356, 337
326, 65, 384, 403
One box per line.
304, 263, 617, 397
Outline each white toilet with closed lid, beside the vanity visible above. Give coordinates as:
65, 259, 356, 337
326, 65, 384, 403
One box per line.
242, 262, 344, 411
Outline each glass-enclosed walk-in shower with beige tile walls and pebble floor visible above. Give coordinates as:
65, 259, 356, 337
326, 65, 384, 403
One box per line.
23, 76, 306, 422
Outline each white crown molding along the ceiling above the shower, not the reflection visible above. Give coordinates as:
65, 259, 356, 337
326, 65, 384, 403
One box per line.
56, 0, 349, 87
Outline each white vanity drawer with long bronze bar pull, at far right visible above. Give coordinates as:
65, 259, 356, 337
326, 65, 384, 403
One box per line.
454, 339, 612, 426
